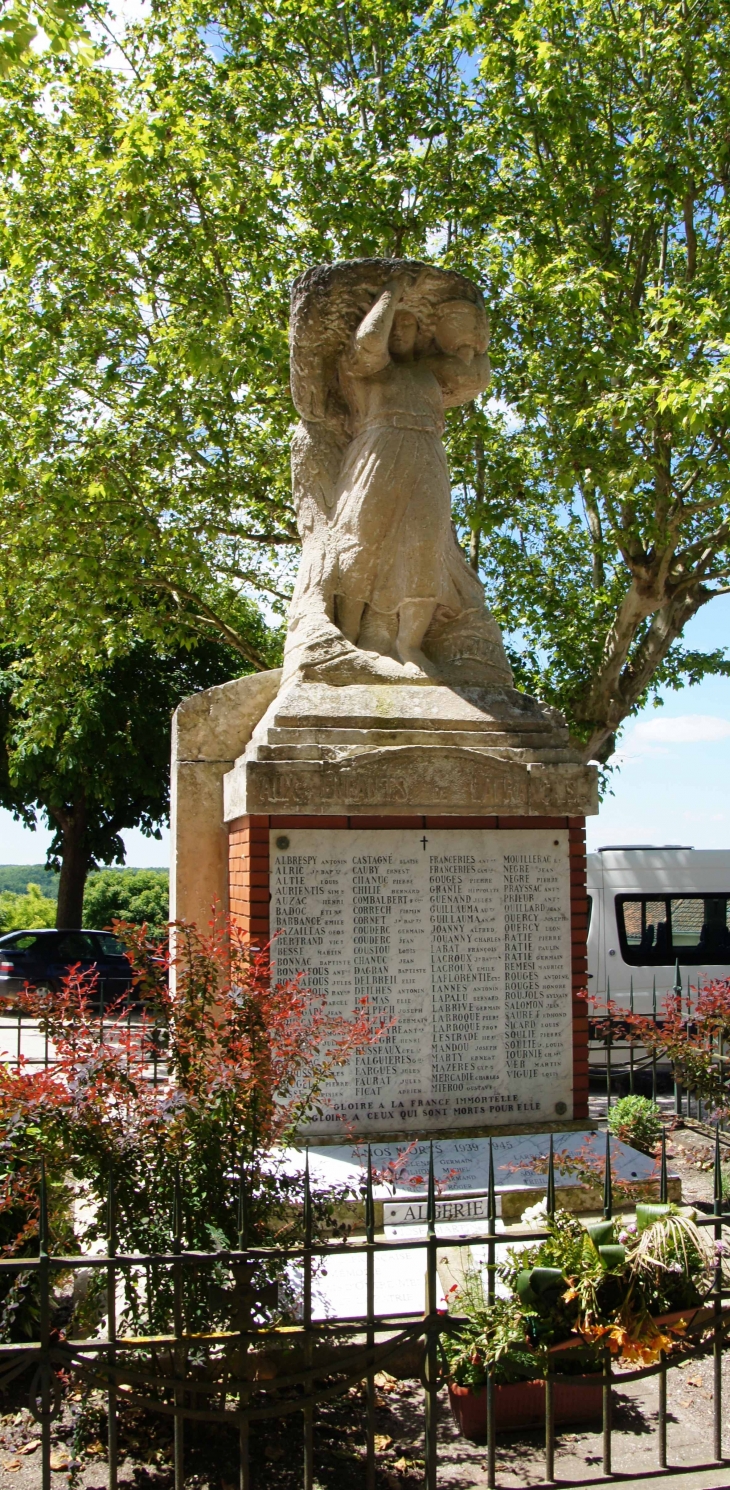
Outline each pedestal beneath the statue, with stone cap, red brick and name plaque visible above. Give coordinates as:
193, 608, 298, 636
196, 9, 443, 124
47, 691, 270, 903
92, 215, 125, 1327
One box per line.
223, 682, 596, 1141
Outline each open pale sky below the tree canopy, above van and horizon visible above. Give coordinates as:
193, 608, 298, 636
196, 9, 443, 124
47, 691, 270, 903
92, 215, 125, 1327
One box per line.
0, 595, 730, 867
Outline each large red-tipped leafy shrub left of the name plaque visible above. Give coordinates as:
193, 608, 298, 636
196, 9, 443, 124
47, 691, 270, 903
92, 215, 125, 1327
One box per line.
0, 922, 381, 1329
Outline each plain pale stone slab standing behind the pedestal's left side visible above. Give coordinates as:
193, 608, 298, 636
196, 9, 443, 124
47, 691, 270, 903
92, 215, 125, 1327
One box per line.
170, 669, 282, 927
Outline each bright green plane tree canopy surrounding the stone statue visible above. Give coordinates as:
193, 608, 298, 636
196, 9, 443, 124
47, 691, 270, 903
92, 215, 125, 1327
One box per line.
0, 0, 730, 760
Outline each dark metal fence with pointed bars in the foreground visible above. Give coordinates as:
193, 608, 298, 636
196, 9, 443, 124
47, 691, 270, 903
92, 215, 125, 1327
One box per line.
0, 1134, 730, 1490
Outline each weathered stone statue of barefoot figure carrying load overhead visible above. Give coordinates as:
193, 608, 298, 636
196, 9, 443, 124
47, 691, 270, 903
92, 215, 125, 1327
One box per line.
285, 259, 512, 687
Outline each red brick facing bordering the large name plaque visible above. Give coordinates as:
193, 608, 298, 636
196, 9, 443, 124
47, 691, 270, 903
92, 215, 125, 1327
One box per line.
228, 814, 588, 1119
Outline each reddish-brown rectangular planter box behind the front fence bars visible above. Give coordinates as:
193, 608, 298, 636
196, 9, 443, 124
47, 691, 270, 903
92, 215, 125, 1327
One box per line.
448, 1375, 603, 1444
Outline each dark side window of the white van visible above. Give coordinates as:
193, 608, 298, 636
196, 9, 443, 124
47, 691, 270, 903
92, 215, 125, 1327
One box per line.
615, 893, 730, 967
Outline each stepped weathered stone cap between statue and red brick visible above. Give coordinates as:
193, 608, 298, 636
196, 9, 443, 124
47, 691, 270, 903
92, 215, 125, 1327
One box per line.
225, 682, 597, 821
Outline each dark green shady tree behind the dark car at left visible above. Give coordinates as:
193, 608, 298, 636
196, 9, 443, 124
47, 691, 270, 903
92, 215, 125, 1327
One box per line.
0, 642, 242, 927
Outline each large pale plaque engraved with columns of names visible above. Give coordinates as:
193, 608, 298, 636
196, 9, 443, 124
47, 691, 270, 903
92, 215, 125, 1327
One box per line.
271, 828, 572, 1140
